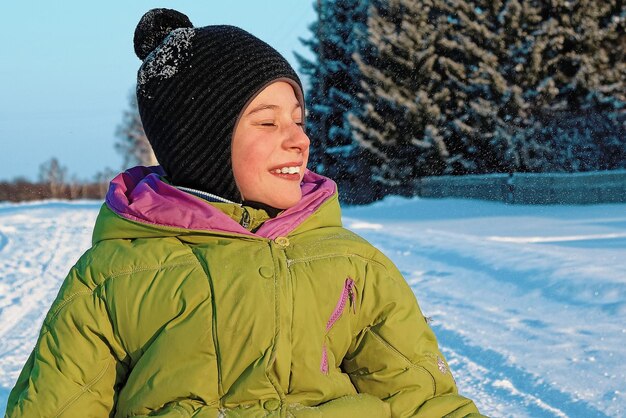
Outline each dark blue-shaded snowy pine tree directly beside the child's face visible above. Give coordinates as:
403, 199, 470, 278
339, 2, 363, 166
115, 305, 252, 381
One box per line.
296, 0, 379, 203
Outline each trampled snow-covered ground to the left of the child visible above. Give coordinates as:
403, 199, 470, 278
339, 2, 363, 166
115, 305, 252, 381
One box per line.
0, 202, 99, 413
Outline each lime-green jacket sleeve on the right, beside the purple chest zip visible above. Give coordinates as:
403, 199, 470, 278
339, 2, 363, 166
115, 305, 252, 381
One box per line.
342, 259, 481, 417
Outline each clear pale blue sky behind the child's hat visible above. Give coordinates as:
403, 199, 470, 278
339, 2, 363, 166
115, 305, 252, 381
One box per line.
0, 0, 315, 180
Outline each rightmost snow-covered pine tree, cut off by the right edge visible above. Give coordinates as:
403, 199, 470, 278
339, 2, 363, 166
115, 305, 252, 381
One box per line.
498, 0, 626, 171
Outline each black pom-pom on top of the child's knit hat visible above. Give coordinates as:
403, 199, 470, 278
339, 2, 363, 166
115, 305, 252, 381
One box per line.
133, 9, 193, 60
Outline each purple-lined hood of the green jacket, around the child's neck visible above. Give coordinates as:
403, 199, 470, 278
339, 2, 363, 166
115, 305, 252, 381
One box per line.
93, 166, 341, 243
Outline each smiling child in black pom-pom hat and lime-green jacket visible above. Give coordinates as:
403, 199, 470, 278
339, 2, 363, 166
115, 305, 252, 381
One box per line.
7, 9, 479, 418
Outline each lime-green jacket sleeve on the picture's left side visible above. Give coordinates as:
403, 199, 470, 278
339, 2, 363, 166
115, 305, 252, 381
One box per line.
5, 268, 124, 418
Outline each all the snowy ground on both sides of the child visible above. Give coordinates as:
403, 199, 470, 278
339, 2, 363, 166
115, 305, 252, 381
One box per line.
0, 198, 626, 418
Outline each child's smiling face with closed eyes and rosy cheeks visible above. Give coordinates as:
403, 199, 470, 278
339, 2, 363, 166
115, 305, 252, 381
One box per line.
232, 81, 309, 209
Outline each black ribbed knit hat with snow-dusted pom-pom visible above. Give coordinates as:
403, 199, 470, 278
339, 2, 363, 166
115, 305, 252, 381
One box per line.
134, 9, 304, 202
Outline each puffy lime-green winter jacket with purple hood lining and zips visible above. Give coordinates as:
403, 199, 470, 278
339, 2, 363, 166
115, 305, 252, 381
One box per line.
5, 168, 479, 418
